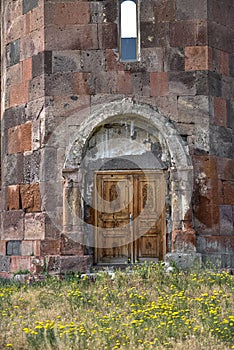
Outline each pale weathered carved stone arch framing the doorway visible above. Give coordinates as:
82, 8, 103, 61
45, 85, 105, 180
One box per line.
63, 98, 195, 258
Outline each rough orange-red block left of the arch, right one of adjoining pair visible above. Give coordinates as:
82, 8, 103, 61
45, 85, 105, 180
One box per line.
20, 183, 41, 212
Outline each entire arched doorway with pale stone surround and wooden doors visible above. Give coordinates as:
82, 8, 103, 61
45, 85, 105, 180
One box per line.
63, 100, 192, 264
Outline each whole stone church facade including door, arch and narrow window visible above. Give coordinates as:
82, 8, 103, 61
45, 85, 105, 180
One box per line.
0, 0, 234, 272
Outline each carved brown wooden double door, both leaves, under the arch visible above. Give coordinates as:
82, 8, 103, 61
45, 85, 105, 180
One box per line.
95, 170, 165, 264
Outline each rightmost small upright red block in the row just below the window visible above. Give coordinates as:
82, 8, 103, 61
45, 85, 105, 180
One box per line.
150, 72, 168, 96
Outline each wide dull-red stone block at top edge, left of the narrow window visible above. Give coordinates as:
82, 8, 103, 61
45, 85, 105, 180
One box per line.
54, 1, 90, 25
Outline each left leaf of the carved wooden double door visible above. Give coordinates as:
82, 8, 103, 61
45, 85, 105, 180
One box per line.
95, 174, 133, 263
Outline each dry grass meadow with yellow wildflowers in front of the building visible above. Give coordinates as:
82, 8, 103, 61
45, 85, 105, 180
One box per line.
0, 264, 234, 350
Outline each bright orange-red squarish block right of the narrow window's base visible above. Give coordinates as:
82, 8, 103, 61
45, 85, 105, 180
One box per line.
185, 46, 212, 70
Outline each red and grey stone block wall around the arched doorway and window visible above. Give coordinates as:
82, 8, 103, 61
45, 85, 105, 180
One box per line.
0, 0, 234, 270
